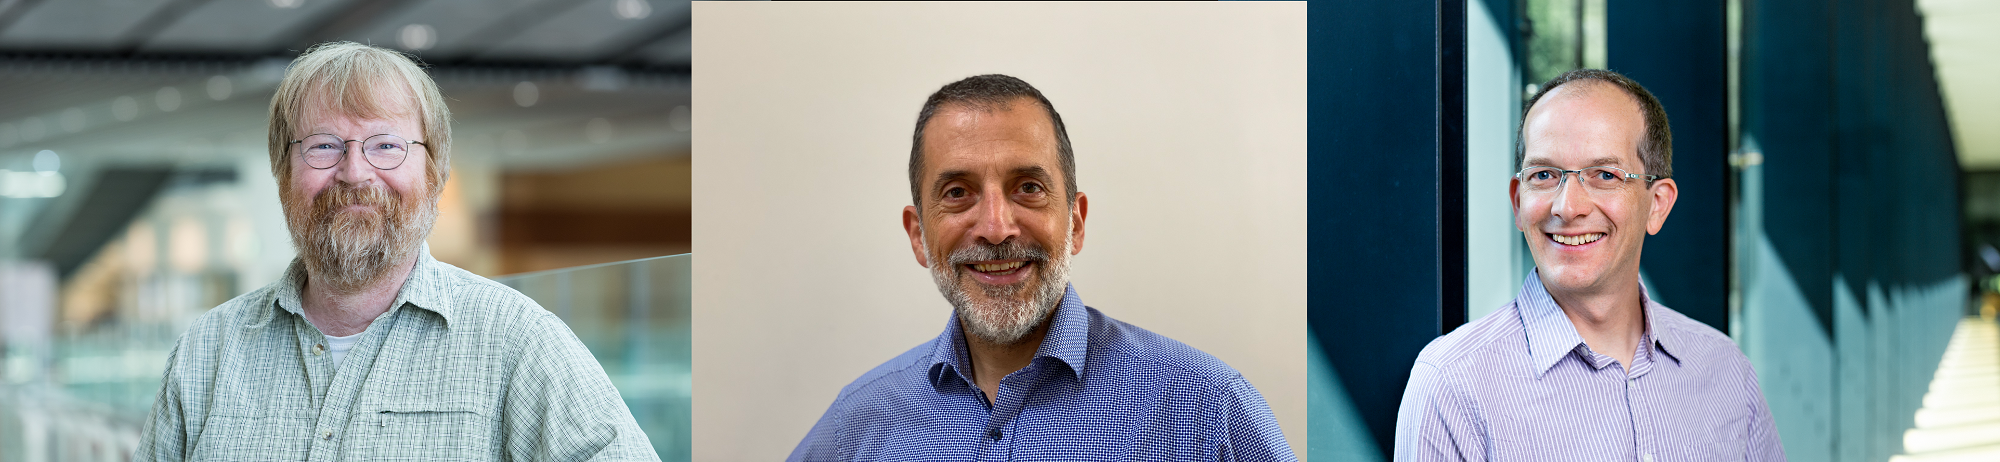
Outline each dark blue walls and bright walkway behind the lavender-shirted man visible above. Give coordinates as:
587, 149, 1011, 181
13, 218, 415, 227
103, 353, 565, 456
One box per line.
1308, 0, 2000, 462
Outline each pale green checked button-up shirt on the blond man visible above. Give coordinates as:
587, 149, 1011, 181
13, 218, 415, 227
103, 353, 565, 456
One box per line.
134, 246, 660, 460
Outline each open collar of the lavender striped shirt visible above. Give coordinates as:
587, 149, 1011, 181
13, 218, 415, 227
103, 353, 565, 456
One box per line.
1514, 270, 1680, 378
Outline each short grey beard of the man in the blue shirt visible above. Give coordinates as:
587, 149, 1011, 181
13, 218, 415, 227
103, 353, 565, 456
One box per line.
924, 229, 1070, 344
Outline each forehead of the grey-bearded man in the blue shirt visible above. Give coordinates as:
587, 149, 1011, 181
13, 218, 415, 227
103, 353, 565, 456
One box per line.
924, 100, 1058, 172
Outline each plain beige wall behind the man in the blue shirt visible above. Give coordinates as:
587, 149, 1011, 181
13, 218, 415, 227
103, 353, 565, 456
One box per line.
692, 2, 1306, 460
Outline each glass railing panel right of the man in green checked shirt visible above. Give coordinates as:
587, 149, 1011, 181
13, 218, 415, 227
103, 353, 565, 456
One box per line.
494, 254, 694, 462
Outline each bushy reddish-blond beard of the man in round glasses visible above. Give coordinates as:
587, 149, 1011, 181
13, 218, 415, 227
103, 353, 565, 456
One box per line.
284, 182, 438, 294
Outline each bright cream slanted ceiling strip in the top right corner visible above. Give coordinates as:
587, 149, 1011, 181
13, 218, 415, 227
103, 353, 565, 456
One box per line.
1916, 0, 2000, 170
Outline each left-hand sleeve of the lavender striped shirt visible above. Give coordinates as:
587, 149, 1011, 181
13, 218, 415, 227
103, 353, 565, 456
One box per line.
1396, 362, 1486, 462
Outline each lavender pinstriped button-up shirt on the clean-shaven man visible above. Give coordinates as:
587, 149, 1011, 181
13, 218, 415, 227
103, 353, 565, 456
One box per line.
1396, 272, 1784, 462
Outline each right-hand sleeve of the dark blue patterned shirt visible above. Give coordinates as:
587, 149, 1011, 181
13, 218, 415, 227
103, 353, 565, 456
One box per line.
1210, 374, 1298, 462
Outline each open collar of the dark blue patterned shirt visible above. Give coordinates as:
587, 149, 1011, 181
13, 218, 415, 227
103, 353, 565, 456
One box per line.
930, 286, 1090, 386
